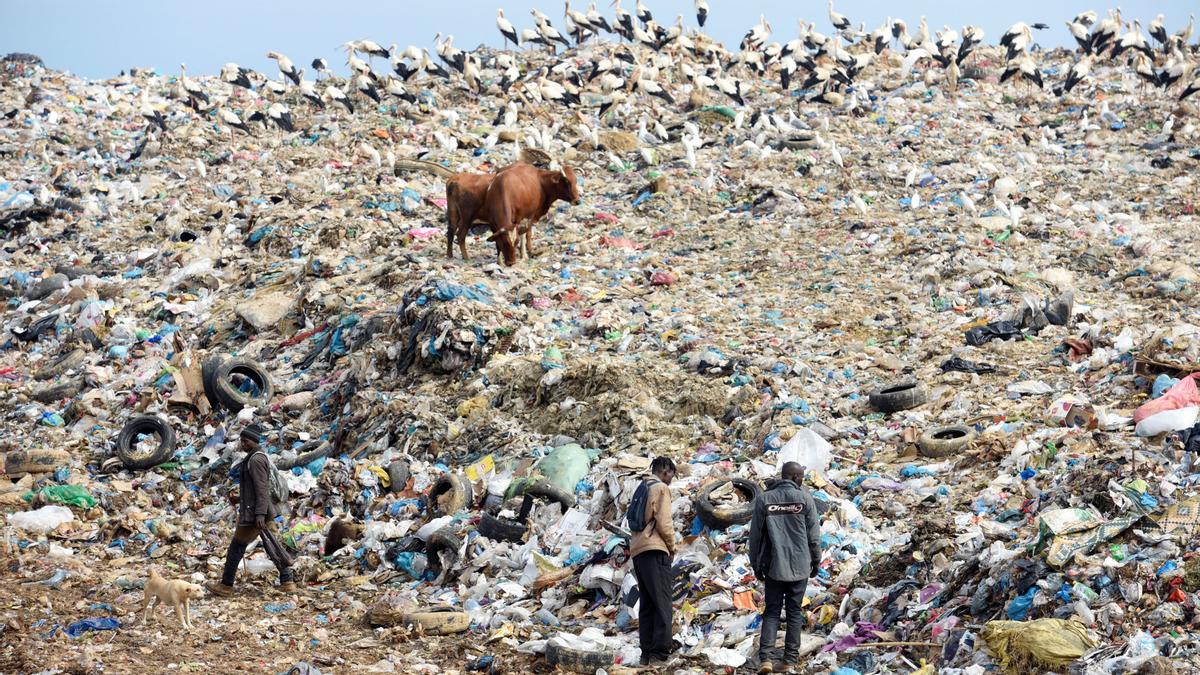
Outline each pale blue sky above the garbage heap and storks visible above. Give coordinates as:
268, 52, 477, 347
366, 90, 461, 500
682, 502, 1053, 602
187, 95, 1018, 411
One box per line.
0, 0, 1200, 78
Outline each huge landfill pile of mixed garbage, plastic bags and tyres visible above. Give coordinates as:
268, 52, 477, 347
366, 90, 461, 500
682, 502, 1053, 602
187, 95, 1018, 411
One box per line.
0, 10, 1200, 675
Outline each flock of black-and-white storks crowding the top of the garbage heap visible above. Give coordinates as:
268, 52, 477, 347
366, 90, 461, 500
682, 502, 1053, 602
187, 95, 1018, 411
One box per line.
142, 0, 1200, 145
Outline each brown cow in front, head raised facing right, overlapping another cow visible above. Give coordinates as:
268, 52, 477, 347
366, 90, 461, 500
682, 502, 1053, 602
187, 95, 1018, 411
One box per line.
476, 162, 582, 265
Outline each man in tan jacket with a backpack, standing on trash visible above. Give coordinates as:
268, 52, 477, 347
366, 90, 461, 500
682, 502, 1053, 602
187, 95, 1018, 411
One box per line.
629, 458, 676, 667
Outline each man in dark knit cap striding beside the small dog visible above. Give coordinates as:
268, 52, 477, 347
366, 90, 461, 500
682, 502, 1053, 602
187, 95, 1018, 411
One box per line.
208, 424, 296, 597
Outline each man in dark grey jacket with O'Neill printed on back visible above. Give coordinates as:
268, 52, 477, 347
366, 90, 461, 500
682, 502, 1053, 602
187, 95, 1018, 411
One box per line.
750, 461, 821, 673
